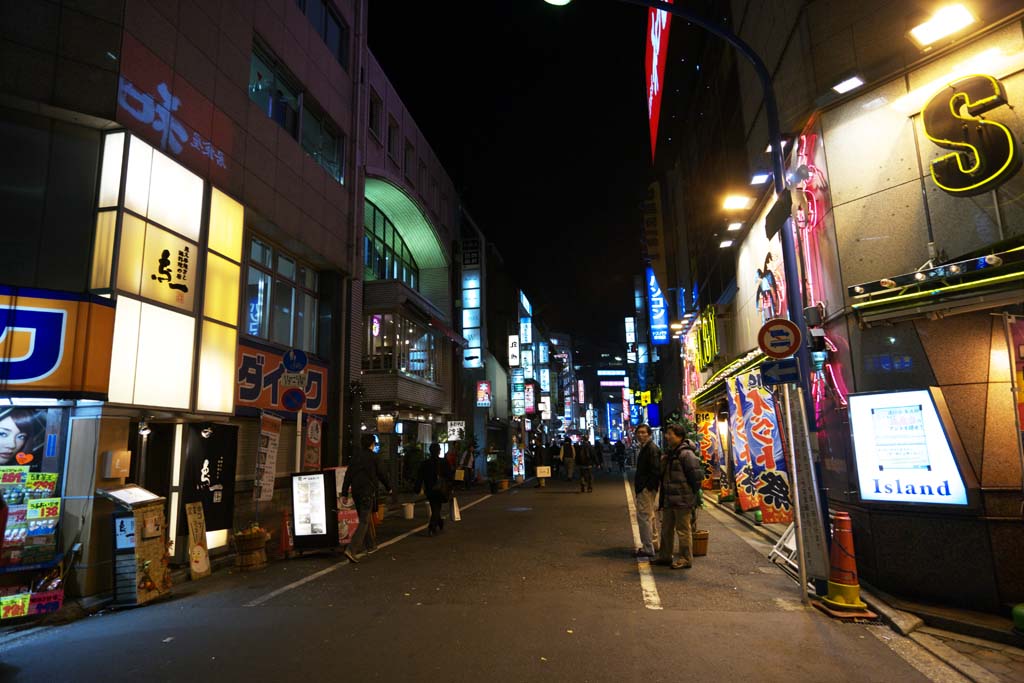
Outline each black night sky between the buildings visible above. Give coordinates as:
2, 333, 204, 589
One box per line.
369, 0, 651, 342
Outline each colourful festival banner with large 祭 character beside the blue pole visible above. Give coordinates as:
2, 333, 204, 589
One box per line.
735, 372, 793, 524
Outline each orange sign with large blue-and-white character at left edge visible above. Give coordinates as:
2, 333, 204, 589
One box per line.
0, 287, 114, 398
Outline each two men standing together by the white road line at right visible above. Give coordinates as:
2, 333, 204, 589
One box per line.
634, 424, 703, 569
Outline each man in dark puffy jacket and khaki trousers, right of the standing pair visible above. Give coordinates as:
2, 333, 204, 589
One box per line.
655, 424, 703, 569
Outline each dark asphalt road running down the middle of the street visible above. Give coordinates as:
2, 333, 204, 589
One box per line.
0, 474, 950, 683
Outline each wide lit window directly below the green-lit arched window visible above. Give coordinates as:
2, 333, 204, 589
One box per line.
362, 313, 441, 384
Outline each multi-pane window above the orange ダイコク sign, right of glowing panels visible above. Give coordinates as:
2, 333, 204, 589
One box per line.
244, 238, 317, 353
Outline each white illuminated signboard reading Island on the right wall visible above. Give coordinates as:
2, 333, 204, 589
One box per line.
849, 389, 968, 506
